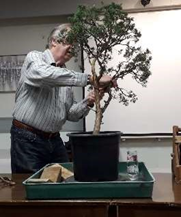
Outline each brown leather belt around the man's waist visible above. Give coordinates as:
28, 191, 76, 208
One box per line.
13, 119, 59, 139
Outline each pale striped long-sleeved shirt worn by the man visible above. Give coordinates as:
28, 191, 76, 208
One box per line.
13, 49, 89, 132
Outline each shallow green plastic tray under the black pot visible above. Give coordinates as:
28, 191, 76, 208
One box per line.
23, 162, 155, 199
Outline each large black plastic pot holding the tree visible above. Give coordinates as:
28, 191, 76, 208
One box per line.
67, 131, 121, 182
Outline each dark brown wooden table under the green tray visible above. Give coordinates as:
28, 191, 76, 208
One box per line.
0, 174, 181, 217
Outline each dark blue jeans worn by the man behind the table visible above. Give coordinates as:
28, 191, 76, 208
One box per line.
11, 125, 69, 173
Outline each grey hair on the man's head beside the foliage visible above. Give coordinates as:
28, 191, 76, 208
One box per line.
46, 23, 71, 48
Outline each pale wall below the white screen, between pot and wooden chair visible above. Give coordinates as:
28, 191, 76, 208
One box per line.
119, 137, 172, 173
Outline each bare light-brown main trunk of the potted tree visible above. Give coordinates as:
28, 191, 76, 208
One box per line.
91, 59, 102, 135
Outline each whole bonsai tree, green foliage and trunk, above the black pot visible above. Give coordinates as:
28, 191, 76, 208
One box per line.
67, 3, 151, 134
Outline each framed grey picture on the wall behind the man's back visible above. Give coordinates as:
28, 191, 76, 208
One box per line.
0, 54, 26, 93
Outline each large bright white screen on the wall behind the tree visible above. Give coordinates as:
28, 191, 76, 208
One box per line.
85, 10, 181, 133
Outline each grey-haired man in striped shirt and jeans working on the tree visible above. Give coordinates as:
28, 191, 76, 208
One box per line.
11, 24, 112, 173
